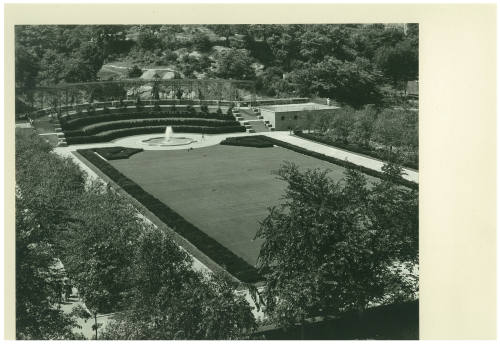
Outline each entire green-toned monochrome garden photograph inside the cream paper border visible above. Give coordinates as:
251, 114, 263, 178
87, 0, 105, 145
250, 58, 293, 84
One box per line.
15, 18, 419, 340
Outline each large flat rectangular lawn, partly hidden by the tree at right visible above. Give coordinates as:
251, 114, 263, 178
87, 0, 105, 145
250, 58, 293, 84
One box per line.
109, 145, 372, 265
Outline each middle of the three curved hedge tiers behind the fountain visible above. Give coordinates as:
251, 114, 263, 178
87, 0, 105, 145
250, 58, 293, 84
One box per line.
64, 118, 240, 138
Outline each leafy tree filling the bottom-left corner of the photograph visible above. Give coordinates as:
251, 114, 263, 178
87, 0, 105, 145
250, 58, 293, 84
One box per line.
16, 196, 81, 340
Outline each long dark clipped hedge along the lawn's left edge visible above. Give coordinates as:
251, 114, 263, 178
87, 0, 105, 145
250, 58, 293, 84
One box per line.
77, 149, 261, 283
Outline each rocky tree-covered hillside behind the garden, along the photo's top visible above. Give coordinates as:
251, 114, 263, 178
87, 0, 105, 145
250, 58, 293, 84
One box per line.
16, 24, 418, 108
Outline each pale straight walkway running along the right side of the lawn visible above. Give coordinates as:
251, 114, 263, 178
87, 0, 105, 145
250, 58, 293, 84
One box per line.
264, 131, 418, 183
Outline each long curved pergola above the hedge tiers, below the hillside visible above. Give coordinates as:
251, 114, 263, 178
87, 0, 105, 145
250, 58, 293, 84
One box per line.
16, 78, 255, 113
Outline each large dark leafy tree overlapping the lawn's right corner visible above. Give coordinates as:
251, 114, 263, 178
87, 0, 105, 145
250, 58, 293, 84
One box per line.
256, 163, 418, 326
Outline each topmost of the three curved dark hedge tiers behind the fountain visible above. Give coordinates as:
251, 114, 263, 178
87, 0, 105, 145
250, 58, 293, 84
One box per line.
60, 109, 234, 131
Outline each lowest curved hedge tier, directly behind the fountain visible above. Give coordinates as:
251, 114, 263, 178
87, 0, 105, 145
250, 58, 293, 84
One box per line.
66, 126, 246, 145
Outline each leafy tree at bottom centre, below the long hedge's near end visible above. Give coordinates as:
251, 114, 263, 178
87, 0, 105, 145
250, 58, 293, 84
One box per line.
102, 227, 255, 340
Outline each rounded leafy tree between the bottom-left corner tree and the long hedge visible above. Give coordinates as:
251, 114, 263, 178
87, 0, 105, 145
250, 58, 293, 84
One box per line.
63, 182, 142, 314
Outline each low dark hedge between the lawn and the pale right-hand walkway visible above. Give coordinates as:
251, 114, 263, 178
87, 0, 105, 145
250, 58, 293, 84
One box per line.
225, 135, 418, 190
